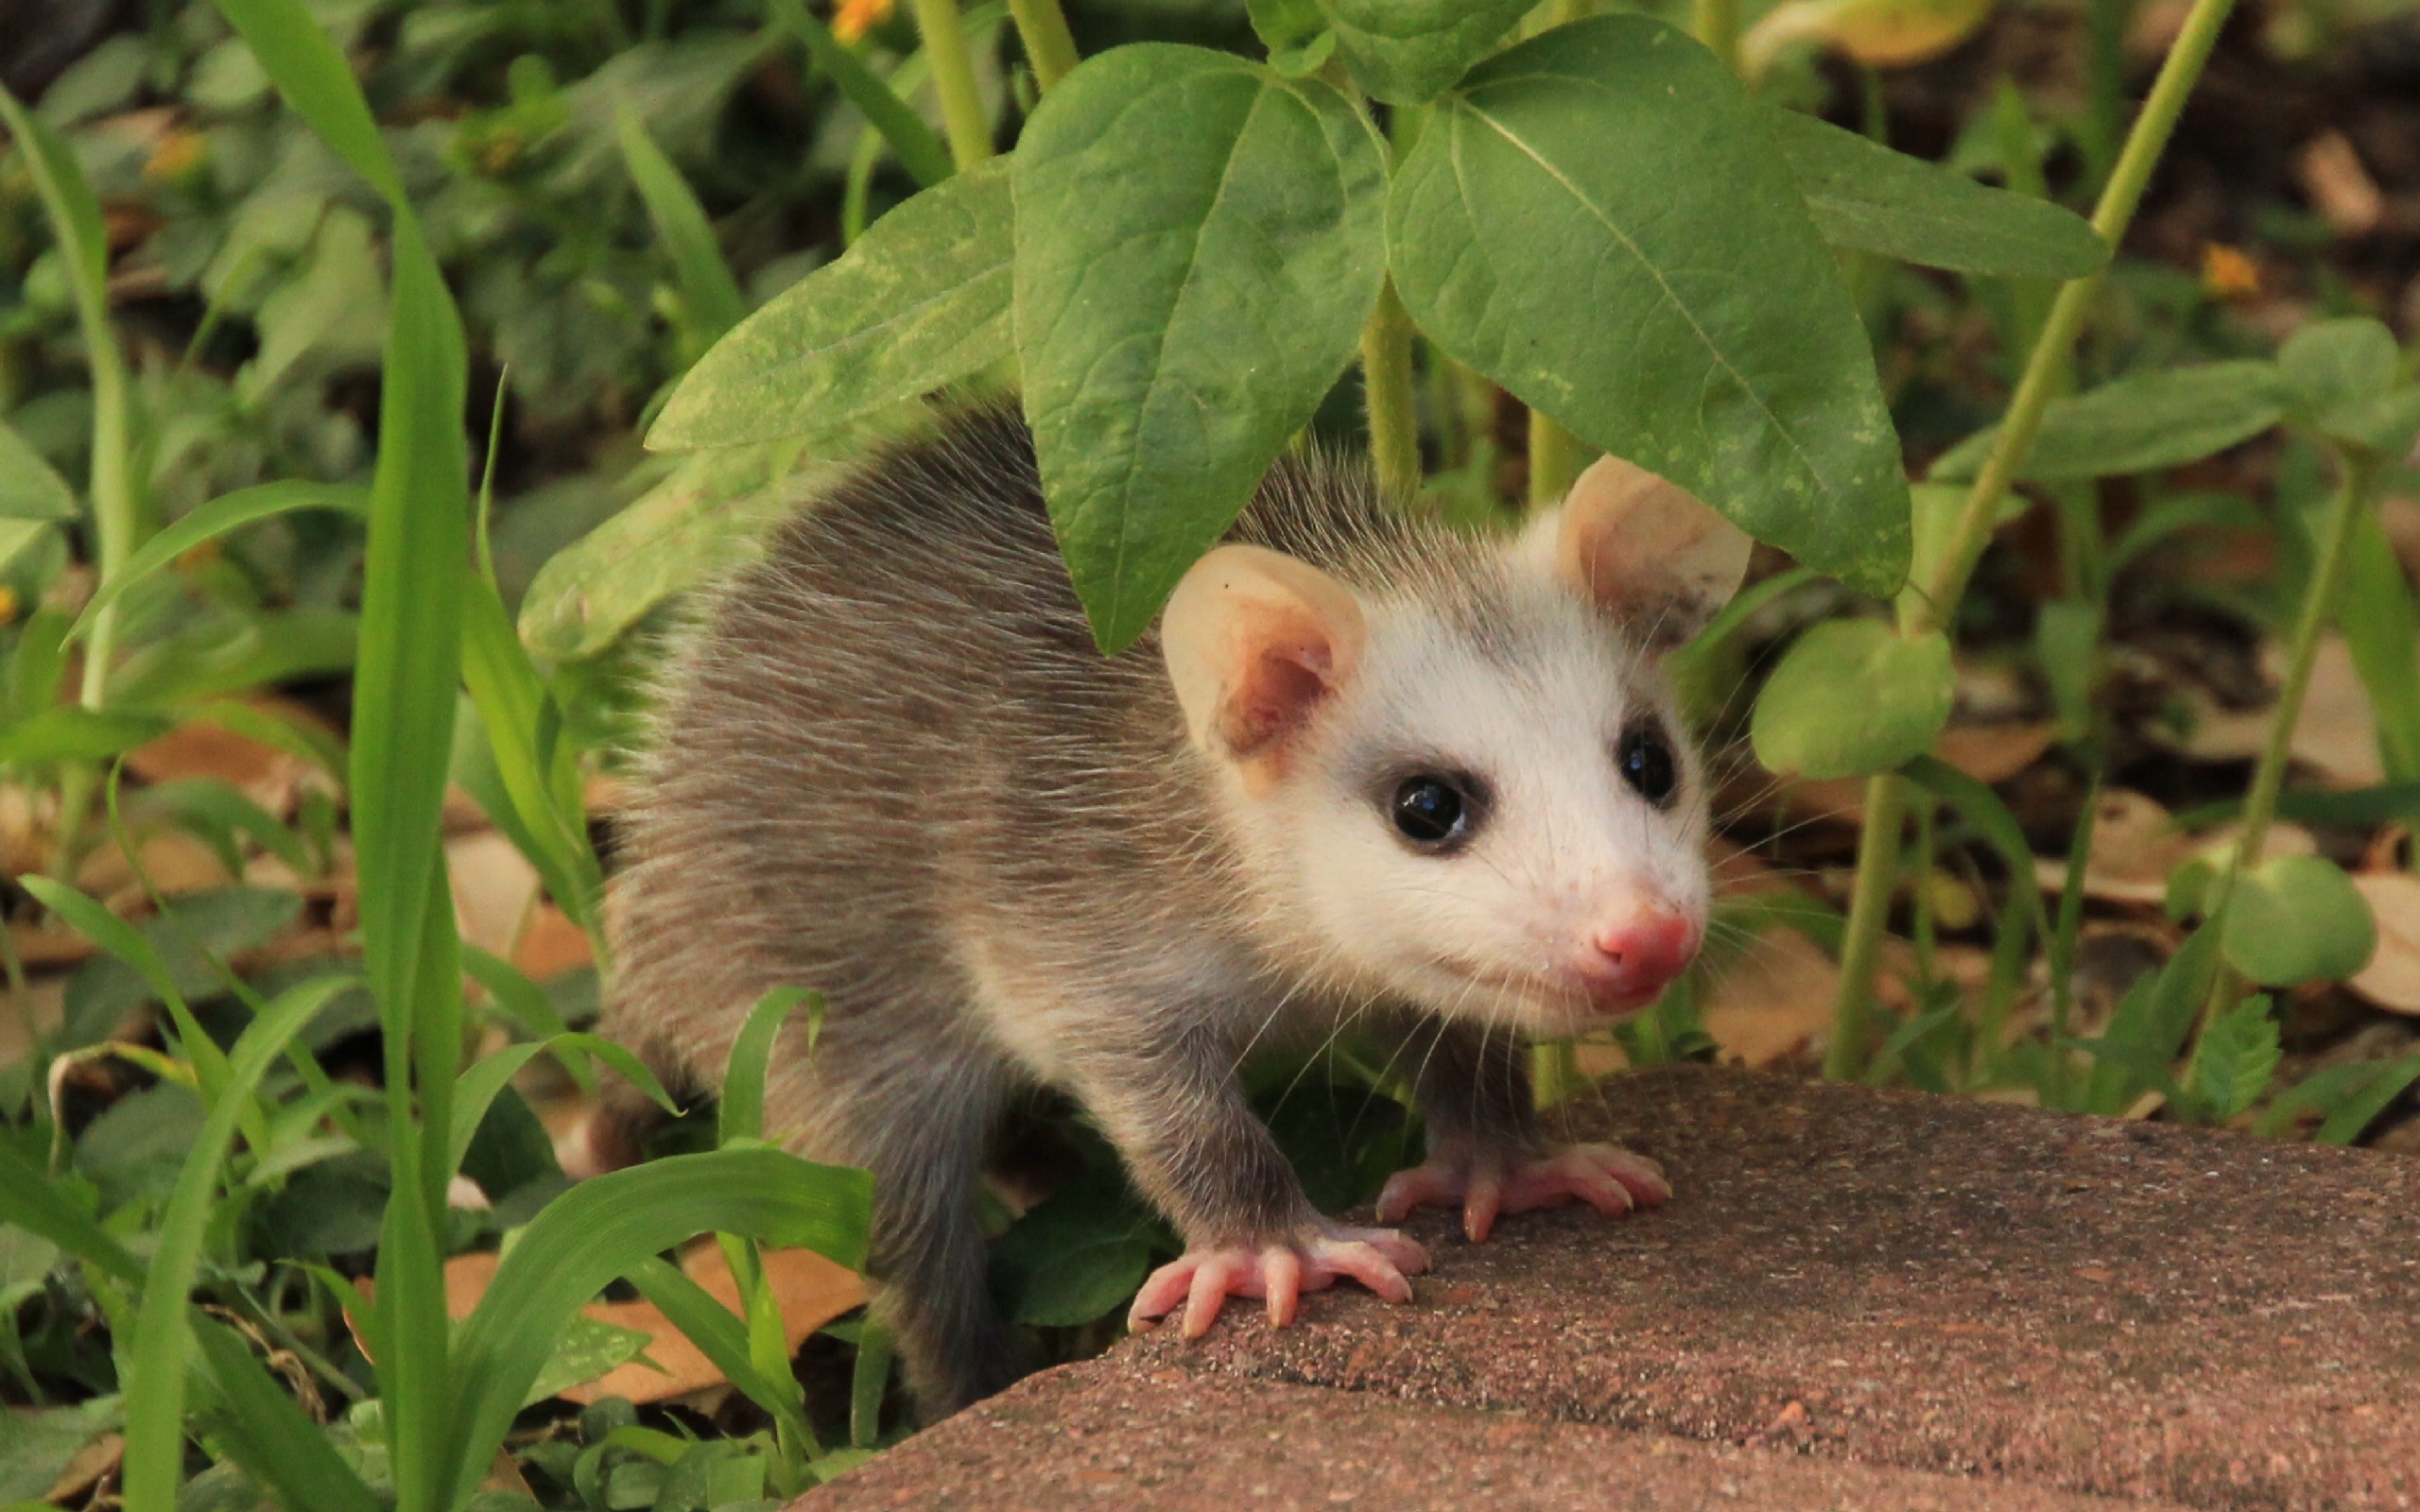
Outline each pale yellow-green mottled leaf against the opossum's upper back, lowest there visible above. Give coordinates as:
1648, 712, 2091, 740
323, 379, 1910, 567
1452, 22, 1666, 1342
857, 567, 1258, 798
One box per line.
520, 447, 798, 661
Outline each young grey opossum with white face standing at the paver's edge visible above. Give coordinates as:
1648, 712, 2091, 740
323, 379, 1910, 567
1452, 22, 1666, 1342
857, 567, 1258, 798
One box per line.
596, 409, 1750, 1418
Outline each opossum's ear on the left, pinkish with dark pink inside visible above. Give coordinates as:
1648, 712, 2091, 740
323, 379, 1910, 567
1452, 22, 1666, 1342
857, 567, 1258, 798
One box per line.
1159, 547, 1367, 789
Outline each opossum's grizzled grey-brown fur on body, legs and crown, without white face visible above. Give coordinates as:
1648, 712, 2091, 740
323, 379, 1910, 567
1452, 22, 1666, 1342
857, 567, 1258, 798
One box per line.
608, 411, 1645, 1416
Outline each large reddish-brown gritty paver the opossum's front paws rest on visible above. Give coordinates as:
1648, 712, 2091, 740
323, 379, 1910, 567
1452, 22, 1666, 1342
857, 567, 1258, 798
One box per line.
803, 1070, 2420, 1512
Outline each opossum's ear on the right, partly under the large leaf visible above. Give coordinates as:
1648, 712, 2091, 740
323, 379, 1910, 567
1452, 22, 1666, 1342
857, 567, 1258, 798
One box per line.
1525, 457, 1754, 648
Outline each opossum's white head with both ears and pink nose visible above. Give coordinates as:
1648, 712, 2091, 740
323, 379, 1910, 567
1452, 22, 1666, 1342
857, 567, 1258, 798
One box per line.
1162, 459, 1750, 1036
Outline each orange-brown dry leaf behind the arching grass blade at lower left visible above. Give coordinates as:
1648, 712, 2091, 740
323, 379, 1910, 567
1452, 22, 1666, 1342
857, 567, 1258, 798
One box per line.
445, 1244, 866, 1405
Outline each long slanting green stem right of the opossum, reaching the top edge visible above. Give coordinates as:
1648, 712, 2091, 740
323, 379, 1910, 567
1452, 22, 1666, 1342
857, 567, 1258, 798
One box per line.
1820, 0, 2234, 1079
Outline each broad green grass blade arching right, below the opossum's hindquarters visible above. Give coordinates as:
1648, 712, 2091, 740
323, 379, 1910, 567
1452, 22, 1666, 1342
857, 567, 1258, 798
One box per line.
441, 1146, 873, 1504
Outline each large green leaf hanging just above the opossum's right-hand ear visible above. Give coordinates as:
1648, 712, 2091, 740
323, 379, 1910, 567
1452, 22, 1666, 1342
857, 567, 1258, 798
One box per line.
1393, 14, 1910, 593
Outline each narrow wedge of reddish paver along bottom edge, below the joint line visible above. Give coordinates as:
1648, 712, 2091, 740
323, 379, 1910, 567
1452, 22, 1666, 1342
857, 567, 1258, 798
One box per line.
799, 1360, 2187, 1512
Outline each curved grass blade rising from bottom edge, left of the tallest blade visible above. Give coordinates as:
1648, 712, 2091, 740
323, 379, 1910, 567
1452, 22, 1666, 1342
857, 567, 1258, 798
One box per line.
124, 977, 346, 1512
